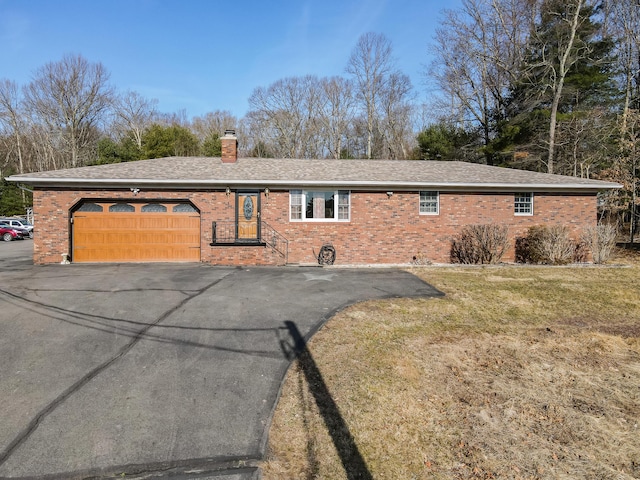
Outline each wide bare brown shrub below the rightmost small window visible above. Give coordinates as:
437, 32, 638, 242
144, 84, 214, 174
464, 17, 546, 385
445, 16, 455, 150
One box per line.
516, 225, 579, 265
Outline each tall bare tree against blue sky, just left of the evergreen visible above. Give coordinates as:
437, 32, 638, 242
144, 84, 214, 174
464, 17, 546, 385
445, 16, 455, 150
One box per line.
427, 0, 536, 164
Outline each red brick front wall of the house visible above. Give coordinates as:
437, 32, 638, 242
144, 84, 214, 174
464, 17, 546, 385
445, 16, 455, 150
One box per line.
34, 188, 596, 265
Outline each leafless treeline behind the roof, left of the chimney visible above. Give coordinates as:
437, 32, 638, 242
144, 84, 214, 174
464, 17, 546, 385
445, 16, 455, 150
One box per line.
0, 55, 237, 176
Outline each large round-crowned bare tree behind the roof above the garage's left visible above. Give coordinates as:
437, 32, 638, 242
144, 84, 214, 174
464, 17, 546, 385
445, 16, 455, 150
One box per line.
25, 55, 113, 167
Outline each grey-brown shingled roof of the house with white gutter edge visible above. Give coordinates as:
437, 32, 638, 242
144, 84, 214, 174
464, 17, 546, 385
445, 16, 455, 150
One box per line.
7, 157, 620, 192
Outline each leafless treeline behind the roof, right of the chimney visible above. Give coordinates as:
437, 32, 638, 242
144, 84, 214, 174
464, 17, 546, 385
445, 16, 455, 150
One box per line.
243, 33, 415, 159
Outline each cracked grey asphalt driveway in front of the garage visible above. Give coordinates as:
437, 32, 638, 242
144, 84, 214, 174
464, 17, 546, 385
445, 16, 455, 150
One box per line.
0, 241, 440, 480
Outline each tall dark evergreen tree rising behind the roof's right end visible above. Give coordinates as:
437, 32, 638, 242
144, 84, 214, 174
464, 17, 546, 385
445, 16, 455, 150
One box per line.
487, 0, 616, 173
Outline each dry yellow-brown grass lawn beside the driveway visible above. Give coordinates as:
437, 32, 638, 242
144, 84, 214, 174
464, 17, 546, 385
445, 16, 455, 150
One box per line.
263, 249, 640, 480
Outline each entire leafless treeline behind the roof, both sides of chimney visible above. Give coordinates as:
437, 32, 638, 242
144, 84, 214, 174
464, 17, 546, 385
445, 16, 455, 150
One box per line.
0, 33, 415, 178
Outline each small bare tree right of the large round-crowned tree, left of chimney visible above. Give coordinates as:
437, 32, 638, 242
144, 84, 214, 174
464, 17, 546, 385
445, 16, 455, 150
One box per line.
113, 91, 158, 149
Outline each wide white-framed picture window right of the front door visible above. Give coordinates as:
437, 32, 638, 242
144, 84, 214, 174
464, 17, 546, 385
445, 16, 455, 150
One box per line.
289, 190, 351, 222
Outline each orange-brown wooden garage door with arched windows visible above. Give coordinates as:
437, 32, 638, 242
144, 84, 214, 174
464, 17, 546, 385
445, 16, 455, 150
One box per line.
72, 201, 200, 262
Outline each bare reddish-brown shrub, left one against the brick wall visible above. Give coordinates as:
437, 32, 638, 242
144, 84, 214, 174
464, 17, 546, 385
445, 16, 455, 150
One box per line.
451, 223, 509, 264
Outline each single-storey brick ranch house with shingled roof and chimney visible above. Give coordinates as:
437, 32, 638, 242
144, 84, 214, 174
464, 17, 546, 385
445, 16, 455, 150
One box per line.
8, 133, 619, 265
